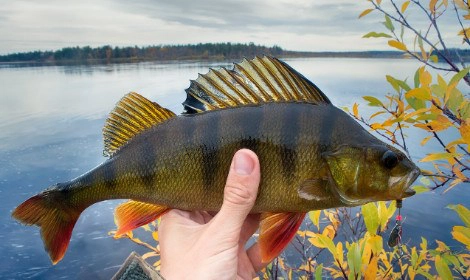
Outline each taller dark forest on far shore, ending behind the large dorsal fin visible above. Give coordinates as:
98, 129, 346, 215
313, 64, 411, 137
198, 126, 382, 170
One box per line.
0, 43, 284, 62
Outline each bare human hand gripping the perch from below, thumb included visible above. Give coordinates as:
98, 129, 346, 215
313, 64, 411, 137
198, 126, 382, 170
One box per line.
159, 149, 266, 280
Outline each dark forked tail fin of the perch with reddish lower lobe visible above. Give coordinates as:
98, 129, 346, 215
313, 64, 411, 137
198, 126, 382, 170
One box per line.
12, 189, 83, 264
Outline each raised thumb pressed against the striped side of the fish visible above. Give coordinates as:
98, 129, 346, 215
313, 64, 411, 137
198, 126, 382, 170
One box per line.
214, 149, 260, 233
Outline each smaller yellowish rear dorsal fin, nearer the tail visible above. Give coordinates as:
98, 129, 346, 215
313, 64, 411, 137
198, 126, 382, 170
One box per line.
103, 92, 175, 156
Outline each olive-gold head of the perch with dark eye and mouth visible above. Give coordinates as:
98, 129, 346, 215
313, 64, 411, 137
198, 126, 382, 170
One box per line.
324, 144, 420, 206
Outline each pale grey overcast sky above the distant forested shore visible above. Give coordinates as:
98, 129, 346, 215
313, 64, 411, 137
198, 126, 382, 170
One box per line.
0, 0, 460, 54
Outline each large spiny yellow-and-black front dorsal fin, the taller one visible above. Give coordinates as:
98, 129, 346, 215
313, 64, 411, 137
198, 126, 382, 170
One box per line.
183, 56, 330, 113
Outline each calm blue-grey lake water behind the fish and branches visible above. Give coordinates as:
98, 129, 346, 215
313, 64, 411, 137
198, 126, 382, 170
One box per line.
0, 58, 470, 279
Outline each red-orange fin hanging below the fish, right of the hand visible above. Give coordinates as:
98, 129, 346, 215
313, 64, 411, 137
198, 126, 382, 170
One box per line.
258, 213, 306, 263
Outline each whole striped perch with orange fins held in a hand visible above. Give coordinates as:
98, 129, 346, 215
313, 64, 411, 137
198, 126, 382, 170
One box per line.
12, 56, 420, 264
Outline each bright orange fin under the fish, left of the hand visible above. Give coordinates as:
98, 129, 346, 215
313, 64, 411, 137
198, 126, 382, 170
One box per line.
114, 200, 170, 236
